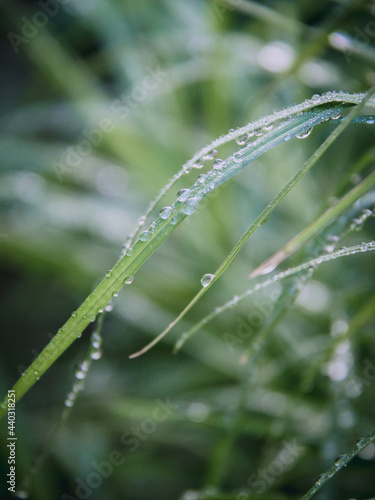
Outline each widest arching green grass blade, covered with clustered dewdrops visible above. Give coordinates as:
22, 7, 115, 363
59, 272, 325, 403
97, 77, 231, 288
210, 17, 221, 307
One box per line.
0, 88, 375, 418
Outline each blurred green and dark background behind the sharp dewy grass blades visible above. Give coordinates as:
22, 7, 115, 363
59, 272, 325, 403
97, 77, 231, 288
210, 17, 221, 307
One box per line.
0, 0, 375, 500
